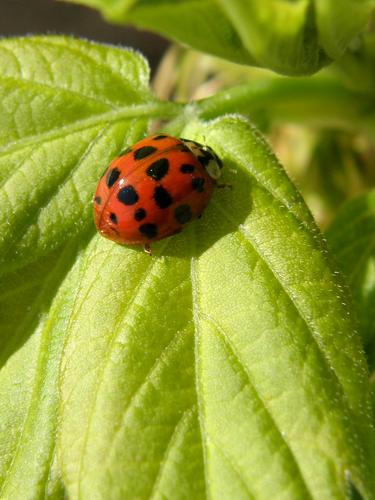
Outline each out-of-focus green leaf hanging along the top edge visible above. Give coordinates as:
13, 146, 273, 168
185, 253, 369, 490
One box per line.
67, 0, 373, 75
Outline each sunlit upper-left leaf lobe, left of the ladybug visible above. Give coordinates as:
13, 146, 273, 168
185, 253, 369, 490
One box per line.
0, 37, 153, 274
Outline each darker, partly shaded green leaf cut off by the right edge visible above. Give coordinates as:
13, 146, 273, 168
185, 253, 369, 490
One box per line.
326, 191, 375, 362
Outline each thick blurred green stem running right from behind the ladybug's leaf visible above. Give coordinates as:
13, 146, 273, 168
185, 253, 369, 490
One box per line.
196, 77, 375, 131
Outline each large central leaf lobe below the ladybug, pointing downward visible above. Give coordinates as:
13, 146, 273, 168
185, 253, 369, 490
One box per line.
55, 118, 371, 498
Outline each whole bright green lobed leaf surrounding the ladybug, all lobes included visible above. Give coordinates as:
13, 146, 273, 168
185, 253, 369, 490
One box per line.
0, 37, 374, 499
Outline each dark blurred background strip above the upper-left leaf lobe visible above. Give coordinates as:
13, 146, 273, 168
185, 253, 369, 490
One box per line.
0, 0, 168, 70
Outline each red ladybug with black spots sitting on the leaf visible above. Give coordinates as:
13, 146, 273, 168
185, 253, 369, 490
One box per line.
94, 134, 223, 253
